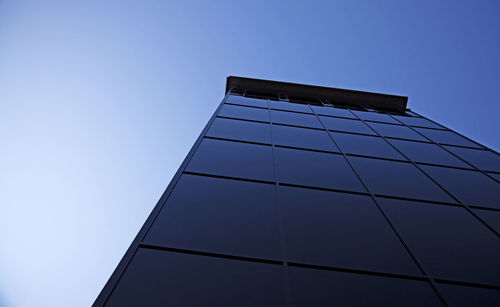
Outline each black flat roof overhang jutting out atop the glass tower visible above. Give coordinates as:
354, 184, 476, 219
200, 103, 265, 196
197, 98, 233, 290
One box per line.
226, 76, 408, 111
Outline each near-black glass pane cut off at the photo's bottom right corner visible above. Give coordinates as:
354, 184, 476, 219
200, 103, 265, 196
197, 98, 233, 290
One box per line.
437, 283, 500, 307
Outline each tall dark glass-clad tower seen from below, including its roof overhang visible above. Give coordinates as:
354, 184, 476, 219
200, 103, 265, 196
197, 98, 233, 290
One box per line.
95, 77, 500, 306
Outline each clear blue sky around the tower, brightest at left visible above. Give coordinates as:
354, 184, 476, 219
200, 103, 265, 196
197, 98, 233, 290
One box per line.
0, 0, 500, 306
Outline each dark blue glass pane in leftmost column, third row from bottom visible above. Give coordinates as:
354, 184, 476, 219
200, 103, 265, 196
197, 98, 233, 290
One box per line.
187, 139, 274, 181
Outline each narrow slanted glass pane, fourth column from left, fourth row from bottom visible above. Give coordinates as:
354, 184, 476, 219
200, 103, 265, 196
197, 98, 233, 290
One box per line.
389, 140, 470, 168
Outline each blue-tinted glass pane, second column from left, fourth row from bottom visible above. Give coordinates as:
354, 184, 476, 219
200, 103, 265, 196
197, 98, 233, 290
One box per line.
272, 125, 338, 152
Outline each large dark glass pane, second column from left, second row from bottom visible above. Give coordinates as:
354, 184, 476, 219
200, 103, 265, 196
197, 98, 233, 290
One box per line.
279, 186, 419, 274
